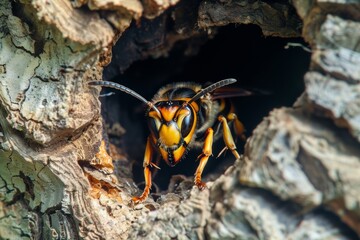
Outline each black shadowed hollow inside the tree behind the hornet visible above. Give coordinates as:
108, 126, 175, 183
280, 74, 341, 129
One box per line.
103, 25, 310, 192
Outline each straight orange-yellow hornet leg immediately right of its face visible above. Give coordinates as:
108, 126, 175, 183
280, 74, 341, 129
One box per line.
194, 128, 214, 190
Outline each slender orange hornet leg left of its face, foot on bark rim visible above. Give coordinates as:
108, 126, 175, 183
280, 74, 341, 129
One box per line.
132, 137, 153, 203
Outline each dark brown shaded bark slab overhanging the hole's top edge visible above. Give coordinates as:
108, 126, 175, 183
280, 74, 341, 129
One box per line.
199, 0, 301, 37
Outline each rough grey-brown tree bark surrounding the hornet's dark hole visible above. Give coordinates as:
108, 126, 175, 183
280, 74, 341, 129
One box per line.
0, 0, 360, 239
